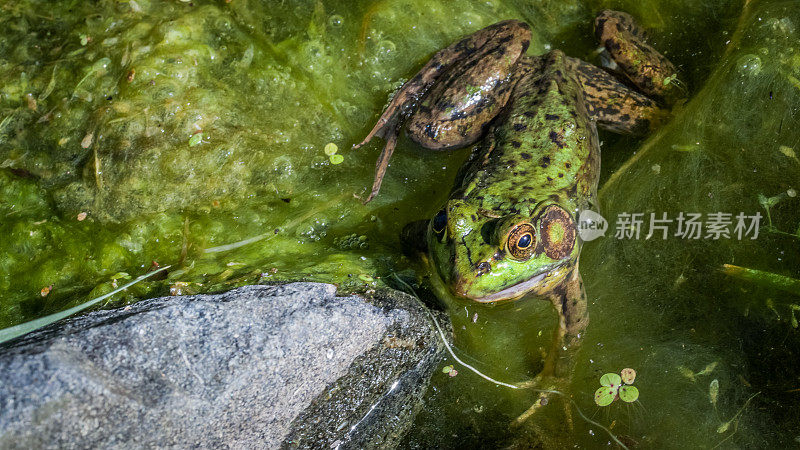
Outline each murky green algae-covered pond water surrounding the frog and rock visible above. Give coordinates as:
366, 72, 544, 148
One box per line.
0, 0, 800, 448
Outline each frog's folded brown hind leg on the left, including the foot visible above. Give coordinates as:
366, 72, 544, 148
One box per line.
354, 20, 530, 202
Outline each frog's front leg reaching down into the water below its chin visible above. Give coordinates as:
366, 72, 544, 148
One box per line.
515, 264, 589, 424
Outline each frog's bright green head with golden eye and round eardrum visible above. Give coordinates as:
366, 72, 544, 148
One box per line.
428, 199, 580, 302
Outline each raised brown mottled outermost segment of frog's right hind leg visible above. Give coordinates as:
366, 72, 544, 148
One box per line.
594, 10, 686, 105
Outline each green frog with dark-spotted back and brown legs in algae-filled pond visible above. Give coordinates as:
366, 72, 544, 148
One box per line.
356, 10, 685, 418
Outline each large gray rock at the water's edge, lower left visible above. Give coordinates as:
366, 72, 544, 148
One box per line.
0, 283, 443, 448
